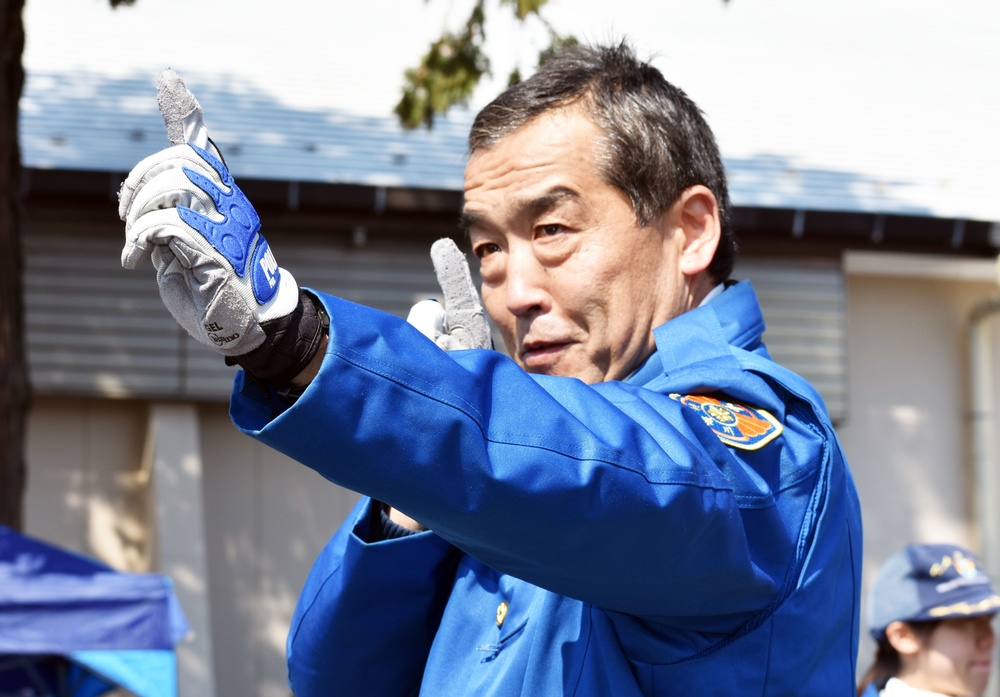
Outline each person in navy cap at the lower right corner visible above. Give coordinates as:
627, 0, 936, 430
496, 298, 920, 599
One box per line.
858, 544, 1000, 697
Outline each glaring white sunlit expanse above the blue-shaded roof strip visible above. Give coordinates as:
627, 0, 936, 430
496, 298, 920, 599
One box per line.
24, 0, 1000, 219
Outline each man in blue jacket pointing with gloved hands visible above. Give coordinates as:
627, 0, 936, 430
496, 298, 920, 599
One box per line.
119, 43, 861, 697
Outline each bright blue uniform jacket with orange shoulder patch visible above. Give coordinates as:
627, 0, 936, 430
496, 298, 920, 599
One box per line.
231, 282, 861, 697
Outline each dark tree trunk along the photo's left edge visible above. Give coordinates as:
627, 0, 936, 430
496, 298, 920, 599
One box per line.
0, 0, 31, 530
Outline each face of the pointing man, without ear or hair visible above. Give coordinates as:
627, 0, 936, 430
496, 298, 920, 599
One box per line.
463, 107, 691, 383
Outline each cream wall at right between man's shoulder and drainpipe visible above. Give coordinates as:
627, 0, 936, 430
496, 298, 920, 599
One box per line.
838, 255, 1000, 680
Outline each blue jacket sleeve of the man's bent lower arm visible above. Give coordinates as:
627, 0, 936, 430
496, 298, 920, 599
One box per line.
287, 499, 457, 697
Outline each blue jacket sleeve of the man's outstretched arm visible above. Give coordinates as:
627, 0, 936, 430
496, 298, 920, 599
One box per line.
231, 295, 829, 631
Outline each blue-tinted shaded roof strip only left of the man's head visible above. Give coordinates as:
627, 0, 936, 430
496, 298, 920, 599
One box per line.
20, 71, 471, 189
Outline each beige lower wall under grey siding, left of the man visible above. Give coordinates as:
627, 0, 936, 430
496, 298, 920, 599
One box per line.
25, 399, 357, 697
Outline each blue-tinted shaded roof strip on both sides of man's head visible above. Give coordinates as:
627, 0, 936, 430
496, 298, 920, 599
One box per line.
20, 66, 982, 219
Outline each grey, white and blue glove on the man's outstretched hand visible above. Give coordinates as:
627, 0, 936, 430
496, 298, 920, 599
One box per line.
118, 70, 324, 388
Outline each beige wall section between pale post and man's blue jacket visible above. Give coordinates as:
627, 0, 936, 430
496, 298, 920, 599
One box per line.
200, 406, 358, 697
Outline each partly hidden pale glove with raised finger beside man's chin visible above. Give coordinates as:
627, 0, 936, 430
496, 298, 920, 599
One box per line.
406, 237, 493, 351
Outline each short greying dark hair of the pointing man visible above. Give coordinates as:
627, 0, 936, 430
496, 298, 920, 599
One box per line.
469, 42, 737, 282
